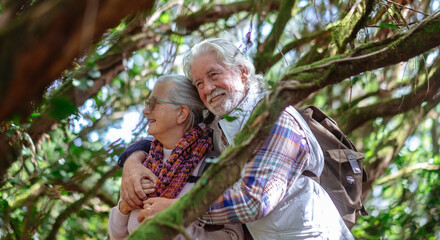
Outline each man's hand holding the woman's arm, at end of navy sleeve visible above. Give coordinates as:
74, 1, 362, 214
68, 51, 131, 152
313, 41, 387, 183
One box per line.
121, 151, 157, 208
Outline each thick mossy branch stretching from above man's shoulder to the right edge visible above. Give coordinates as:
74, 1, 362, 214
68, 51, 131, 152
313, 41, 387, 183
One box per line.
281, 13, 440, 89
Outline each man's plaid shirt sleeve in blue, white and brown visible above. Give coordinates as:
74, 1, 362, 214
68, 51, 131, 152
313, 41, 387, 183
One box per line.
200, 107, 310, 224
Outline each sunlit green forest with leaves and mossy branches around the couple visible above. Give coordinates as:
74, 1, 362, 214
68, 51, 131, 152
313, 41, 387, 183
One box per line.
0, 0, 440, 239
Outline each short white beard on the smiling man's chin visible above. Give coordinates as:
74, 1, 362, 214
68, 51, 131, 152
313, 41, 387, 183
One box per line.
206, 88, 245, 117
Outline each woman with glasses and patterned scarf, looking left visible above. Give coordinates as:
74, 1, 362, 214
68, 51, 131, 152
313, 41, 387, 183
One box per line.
108, 75, 243, 240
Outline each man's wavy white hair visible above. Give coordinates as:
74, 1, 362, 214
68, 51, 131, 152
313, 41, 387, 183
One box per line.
183, 38, 266, 94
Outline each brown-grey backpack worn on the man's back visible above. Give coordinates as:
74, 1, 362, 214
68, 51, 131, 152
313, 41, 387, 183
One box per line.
298, 106, 368, 229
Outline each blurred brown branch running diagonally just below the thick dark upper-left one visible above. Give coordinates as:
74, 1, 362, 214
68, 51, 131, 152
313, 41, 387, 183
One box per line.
0, 19, 170, 186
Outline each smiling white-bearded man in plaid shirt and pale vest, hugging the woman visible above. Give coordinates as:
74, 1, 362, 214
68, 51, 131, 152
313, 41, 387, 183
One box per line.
121, 39, 354, 239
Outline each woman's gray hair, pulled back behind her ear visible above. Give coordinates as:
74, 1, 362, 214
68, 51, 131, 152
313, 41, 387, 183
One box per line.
156, 74, 205, 130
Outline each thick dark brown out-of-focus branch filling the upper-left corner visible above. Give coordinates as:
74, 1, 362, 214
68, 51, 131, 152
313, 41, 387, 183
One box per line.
0, 0, 154, 121
